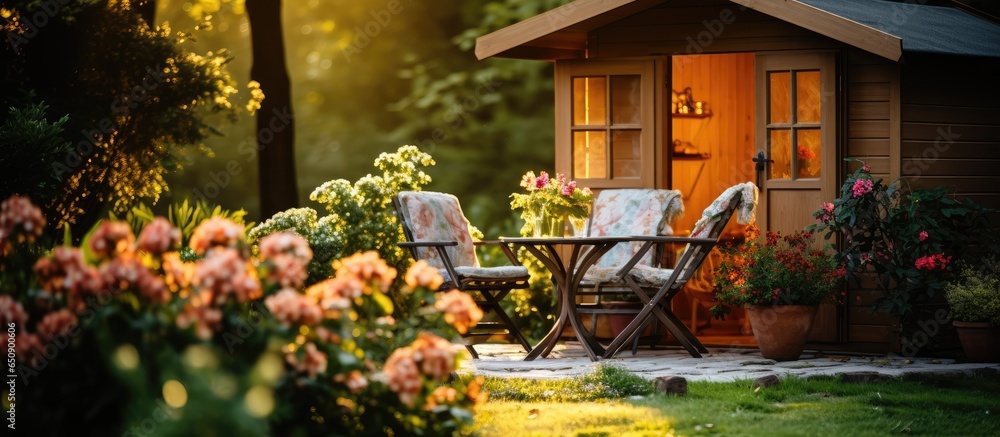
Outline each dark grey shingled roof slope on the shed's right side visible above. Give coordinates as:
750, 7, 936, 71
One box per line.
799, 0, 1000, 57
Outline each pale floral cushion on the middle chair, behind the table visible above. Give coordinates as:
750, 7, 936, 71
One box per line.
587, 188, 684, 274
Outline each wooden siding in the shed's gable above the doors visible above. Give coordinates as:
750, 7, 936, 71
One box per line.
588, 0, 843, 58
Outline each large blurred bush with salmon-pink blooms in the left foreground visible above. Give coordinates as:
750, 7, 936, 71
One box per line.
0, 198, 485, 435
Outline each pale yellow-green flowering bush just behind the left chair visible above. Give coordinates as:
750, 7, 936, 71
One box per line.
248, 146, 434, 284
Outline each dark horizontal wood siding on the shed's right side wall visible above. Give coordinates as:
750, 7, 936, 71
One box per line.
900, 55, 1000, 224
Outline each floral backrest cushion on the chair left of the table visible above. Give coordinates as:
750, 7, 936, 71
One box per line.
399, 191, 479, 269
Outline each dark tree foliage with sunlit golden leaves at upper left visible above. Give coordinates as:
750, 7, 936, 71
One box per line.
0, 0, 244, 235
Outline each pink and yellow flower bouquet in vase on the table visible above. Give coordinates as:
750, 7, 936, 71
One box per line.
510, 171, 594, 237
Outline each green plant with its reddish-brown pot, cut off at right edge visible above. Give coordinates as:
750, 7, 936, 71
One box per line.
944, 254, 1000, 363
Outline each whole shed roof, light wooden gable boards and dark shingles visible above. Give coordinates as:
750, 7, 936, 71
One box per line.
476, 0, 1000, 61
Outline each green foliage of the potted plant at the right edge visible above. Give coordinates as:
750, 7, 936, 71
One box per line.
944, 255, 1000, 326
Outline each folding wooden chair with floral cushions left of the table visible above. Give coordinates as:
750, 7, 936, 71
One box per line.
393, 191, 531, 358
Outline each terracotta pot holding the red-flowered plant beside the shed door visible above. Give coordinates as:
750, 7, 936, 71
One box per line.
746, 305, 819, 361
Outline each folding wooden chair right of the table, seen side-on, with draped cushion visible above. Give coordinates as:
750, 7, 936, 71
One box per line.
592, 182, 758, 358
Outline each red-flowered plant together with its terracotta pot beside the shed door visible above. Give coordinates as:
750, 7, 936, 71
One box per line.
712, 225, 845, 361
